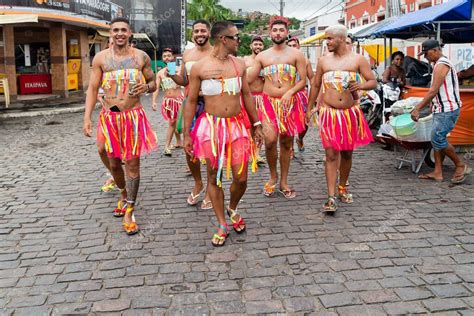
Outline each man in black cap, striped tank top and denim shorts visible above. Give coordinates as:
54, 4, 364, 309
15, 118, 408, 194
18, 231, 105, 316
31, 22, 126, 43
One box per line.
411, 39, 472, 184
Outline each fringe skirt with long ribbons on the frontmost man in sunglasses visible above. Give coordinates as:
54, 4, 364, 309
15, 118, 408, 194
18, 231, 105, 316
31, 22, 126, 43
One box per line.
191, 112, 257, 186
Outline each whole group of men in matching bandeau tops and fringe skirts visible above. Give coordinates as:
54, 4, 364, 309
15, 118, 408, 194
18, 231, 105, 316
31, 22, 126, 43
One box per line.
84, 16, 470, 246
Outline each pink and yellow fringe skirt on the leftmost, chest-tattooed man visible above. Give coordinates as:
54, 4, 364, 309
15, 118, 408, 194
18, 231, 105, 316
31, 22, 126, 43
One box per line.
97, 106, 157, 160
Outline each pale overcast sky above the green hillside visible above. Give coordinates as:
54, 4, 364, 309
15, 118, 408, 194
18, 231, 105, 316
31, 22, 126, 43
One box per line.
221, 0, 328, 20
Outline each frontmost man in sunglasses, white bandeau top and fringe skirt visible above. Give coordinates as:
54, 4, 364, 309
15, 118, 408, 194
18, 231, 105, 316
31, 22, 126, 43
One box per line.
184, 21, 263, 246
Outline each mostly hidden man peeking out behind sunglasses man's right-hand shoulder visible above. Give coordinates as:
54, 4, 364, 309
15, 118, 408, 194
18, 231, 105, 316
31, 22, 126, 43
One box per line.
244, 36, 265, 164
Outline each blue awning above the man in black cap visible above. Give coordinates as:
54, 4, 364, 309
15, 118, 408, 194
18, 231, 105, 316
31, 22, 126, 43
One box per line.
377, 0, 471, 35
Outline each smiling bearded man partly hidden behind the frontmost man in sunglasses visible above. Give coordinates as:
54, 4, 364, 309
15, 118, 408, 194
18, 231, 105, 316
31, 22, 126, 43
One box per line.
165, 20, 212, 210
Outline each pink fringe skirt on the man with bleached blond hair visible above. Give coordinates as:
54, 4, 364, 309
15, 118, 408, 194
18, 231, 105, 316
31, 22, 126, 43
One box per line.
319, 104, 374, 151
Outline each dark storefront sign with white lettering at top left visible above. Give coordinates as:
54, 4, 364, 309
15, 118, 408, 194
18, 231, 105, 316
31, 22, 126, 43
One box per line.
0, 0, 112, 21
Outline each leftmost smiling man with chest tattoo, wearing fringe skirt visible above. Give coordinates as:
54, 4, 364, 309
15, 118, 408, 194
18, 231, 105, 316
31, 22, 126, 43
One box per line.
83, 17, 156, 235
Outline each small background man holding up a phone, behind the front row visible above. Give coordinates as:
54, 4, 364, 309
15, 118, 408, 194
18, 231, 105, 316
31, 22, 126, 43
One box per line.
152, 48, 184, 156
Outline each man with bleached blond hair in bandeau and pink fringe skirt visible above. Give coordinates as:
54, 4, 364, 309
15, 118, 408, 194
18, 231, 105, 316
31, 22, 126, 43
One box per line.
306, 25, 377, 214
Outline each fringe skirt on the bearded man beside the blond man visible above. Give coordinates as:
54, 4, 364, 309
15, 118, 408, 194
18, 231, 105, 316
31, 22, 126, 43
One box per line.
259, 93, 306, 136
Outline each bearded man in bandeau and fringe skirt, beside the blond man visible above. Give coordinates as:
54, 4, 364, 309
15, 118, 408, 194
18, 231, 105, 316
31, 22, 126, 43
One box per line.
249, 17, 306, 199
